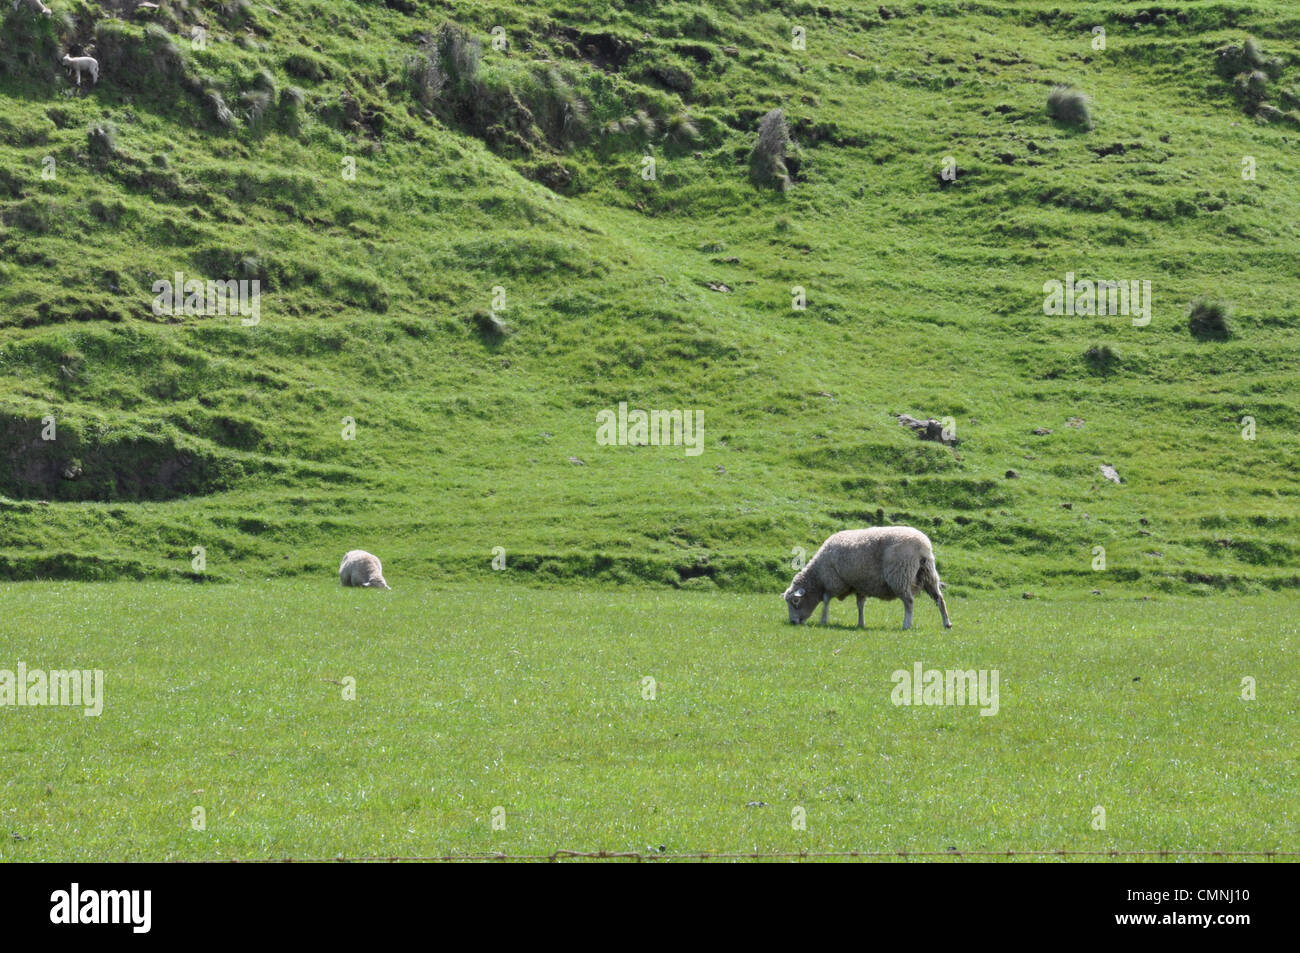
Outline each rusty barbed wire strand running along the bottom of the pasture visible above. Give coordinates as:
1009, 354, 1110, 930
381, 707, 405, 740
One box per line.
198, 849, 1300, 863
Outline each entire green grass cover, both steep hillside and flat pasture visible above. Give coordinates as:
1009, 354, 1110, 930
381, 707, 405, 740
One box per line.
0, 0, 1300, 859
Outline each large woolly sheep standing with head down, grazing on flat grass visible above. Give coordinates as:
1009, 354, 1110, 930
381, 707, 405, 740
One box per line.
785, 527, 953, 629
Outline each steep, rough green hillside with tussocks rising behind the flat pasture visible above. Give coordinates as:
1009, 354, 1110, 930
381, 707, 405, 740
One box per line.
0, 0, 1300, 593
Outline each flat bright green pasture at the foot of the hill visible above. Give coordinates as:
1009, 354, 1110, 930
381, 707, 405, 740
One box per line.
0, 580, 1300, 861
